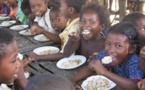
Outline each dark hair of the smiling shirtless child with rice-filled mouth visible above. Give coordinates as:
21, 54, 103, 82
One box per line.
80, 4, 109, 27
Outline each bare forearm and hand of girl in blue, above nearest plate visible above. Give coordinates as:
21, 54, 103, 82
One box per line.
89, 60, 138, 90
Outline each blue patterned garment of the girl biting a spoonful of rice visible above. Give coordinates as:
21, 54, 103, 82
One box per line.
96, 50, 144, 79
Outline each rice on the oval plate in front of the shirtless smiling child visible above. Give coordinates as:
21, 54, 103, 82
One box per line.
62, 59, 82, 68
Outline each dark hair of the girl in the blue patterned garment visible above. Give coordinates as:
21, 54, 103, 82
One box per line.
108, 22, 139, 47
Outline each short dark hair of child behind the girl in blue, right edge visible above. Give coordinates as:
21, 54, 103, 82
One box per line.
122, 12, 145, 25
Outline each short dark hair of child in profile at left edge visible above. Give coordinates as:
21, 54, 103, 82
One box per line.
0, 28, 14, 60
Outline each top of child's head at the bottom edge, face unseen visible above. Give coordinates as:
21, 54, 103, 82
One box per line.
25, 74, 75, 90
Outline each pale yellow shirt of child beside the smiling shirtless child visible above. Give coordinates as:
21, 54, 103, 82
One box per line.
59, 18, 80, 52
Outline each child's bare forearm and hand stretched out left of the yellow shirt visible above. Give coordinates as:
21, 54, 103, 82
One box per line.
30, 24, 61, 43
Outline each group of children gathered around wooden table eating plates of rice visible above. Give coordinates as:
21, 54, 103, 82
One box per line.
0, 0, 145, 90
